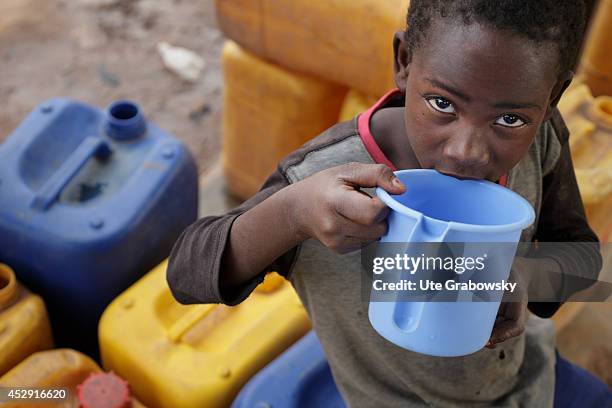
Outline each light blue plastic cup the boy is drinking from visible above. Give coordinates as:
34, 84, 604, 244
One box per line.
369, 170, 535, 357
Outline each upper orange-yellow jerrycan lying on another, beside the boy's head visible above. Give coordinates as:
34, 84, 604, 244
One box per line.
215, 0, 408, 96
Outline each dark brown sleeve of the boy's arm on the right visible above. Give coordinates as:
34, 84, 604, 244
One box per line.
529, 117, 602, 317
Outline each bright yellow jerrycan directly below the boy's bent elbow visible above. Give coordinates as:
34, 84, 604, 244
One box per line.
99, 262, 310, 408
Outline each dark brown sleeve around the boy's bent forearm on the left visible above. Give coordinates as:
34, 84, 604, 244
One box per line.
167, 169, 296, 305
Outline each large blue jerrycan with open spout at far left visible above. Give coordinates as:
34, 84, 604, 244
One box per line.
0, 99, 198, 356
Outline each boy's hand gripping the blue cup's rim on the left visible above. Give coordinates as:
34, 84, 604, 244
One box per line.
291, 163, 406, 254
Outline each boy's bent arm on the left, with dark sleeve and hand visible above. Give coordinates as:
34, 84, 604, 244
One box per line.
167, 159, 405, 305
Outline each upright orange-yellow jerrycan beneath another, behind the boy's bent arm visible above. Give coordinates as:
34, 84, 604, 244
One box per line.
222, 41, 346, 199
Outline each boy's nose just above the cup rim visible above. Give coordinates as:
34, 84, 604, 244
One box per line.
442, 132, 491, 173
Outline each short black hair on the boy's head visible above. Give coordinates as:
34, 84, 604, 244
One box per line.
405, 0, 586, 74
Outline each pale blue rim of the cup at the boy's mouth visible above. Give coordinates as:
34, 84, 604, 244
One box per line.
376, 169, 535, 233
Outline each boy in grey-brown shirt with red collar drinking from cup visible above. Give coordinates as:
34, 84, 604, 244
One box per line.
168, 0, 601, 407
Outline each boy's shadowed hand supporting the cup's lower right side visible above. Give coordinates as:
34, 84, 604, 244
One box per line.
486, 257, 530, 349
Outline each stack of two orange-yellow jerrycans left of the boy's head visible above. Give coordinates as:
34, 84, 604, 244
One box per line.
215, 0, 408, 199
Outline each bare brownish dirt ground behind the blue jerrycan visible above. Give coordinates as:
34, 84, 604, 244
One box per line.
0, 0, 223, 173
